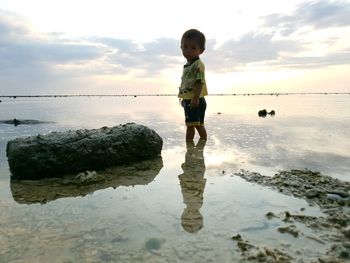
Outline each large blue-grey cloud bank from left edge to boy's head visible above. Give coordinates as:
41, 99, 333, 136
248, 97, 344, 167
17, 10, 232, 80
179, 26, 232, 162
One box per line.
0, 10, 181, 94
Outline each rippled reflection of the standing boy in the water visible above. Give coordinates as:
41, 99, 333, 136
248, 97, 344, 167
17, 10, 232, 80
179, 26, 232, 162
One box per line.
179, 139, 206, 233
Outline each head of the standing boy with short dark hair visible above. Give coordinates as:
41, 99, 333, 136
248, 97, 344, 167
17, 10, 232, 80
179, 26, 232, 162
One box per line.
181, 29, 205, 60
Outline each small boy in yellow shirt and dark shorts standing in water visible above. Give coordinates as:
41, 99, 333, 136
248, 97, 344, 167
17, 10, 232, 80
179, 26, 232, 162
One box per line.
178, 29, 208, 141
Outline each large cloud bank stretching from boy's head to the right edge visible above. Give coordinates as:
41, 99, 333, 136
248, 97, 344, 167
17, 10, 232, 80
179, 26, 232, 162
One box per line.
206, 1, 350, 73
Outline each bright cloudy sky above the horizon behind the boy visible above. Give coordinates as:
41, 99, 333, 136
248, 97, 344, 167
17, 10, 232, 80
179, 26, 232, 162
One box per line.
0, 0, 350, 95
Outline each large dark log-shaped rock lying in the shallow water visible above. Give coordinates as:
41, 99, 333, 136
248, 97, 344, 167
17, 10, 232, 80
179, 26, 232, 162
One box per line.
6, 123, 163, 179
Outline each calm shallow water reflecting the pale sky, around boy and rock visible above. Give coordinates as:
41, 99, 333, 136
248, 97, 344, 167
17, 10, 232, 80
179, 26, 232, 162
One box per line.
0, 95, 350, 262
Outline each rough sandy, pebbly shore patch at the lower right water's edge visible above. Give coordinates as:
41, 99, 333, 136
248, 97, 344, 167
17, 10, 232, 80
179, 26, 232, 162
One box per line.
232, 170, 350, 263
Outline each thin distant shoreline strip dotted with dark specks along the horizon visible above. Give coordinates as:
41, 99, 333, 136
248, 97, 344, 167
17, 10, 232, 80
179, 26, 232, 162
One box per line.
0, 92, 350, 99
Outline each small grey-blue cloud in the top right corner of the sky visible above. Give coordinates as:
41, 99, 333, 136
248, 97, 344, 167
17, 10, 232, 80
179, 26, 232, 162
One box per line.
262, 0, 350, 36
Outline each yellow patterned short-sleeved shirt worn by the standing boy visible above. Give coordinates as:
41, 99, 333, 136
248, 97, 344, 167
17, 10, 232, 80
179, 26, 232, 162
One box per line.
178, 58, 208, 99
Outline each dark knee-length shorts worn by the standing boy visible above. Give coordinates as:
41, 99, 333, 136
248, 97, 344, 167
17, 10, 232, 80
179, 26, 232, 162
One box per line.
181, 97, 207, 126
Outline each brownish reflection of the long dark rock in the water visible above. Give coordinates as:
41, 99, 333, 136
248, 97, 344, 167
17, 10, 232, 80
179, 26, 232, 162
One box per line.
10, 157, 163, 204
